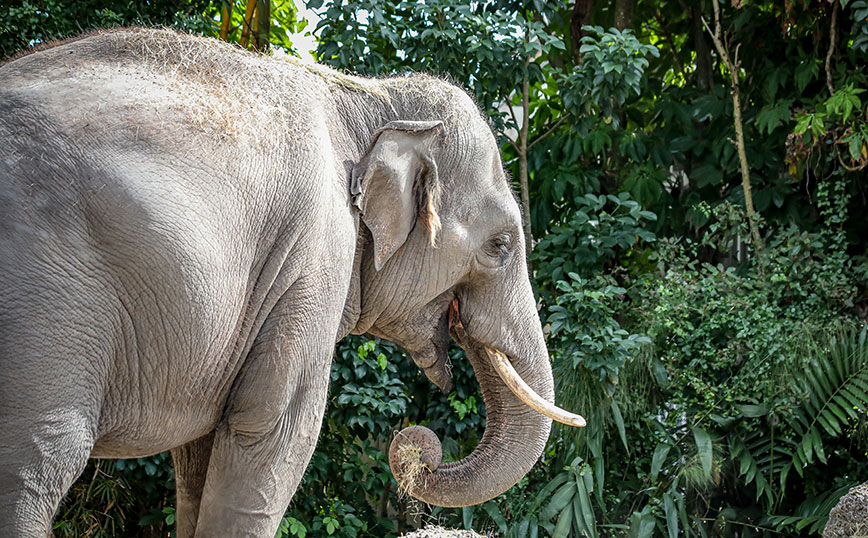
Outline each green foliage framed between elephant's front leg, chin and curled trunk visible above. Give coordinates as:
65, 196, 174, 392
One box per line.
283, 337, 485, 537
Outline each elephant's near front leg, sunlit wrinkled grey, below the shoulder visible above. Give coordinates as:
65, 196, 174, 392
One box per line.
196, 278, 340, 537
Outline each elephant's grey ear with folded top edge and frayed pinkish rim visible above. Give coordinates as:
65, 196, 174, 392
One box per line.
350, 121, 443, 271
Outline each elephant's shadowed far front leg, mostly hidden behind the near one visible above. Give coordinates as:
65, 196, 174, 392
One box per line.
172, 432, 214, 538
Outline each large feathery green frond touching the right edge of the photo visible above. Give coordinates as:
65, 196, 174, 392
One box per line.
790, 327, 868, 474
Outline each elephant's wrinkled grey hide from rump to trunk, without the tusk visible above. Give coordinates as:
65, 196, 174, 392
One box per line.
0, 30, 553, 538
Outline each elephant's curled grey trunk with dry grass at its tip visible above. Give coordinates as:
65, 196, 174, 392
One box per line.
389, 331, 554, 507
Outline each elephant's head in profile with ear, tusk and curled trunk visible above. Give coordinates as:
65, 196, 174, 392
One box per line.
342, 81, 584, 507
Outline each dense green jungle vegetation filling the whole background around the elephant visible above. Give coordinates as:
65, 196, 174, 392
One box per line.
0, 0, 868, 538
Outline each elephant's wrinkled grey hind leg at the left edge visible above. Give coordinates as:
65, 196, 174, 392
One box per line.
0, 310, 105, 538
